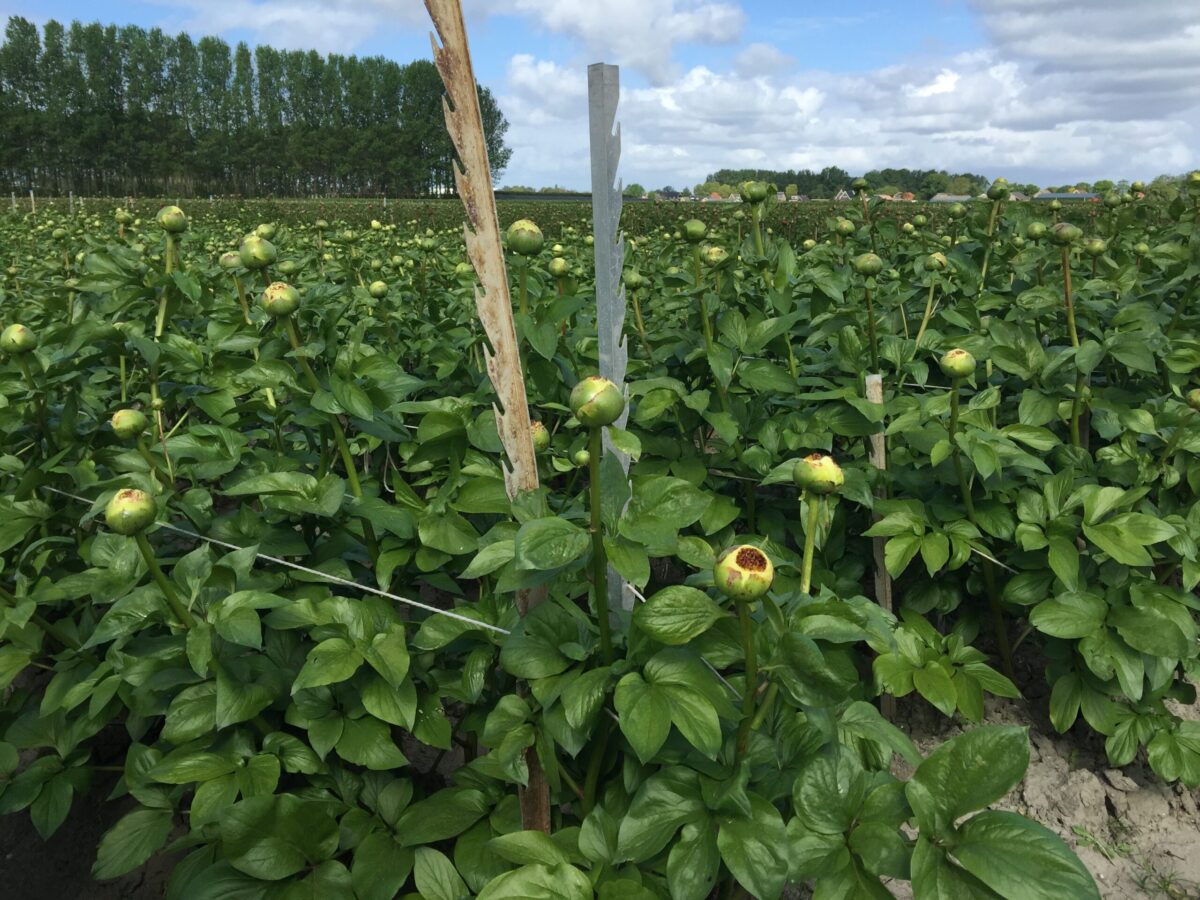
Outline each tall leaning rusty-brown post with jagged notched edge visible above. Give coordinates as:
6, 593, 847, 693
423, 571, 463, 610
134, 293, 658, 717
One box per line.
425, 0, 551, 834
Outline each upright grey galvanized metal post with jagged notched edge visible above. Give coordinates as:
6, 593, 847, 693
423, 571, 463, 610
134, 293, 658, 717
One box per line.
588, 62, 634, 610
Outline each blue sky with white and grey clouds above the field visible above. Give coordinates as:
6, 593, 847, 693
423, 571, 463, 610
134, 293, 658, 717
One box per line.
0, 0, 1200, 188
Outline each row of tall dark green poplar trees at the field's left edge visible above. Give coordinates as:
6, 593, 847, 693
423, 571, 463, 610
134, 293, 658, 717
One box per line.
0, 17, 511, 197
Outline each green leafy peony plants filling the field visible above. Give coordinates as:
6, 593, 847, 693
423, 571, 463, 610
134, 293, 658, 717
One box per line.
0, 172, 1200, 900
